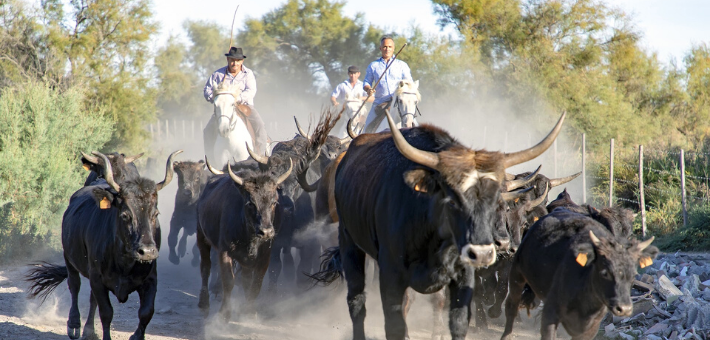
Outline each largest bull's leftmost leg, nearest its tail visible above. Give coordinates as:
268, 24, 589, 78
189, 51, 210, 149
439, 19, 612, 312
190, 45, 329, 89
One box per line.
339, 228, 370, 340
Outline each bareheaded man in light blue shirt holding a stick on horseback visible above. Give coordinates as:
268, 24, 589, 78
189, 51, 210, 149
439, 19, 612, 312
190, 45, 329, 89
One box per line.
363, 36, 412, 133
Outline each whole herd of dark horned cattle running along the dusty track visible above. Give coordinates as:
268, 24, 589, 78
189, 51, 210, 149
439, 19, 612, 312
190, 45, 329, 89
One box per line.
27, 112, 658, 340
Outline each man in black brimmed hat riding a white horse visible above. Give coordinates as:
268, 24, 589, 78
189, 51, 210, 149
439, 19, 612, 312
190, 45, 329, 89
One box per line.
203, 47, 267, 159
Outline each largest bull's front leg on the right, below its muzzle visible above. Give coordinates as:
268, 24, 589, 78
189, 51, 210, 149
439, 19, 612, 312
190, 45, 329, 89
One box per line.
449, 266, 474, 340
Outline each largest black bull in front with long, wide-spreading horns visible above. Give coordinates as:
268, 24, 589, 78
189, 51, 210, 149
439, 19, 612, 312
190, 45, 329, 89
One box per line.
314, 110, 565, 340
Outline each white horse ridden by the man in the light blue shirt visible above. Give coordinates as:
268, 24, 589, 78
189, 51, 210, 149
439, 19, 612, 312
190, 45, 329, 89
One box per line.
375, 80, 422, 132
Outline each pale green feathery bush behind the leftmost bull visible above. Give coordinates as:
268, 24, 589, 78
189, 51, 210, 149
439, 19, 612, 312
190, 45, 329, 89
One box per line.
0, 82, 113, 261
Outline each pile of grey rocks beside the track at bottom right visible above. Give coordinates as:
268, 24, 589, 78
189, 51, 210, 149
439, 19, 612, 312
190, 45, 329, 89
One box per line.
601, 253, 710, 340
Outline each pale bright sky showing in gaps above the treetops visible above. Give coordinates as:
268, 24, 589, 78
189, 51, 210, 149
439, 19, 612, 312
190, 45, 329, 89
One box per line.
153, 0, 710, 64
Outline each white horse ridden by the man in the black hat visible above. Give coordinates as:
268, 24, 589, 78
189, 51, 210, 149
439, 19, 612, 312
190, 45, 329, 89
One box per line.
212, 82, 254, 168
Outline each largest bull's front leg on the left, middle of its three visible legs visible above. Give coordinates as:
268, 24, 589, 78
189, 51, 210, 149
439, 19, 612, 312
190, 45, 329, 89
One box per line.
382, 268, 414, 340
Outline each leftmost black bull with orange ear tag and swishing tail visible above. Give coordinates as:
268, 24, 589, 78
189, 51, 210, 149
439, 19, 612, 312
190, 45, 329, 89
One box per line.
27, 150, 182, 340
